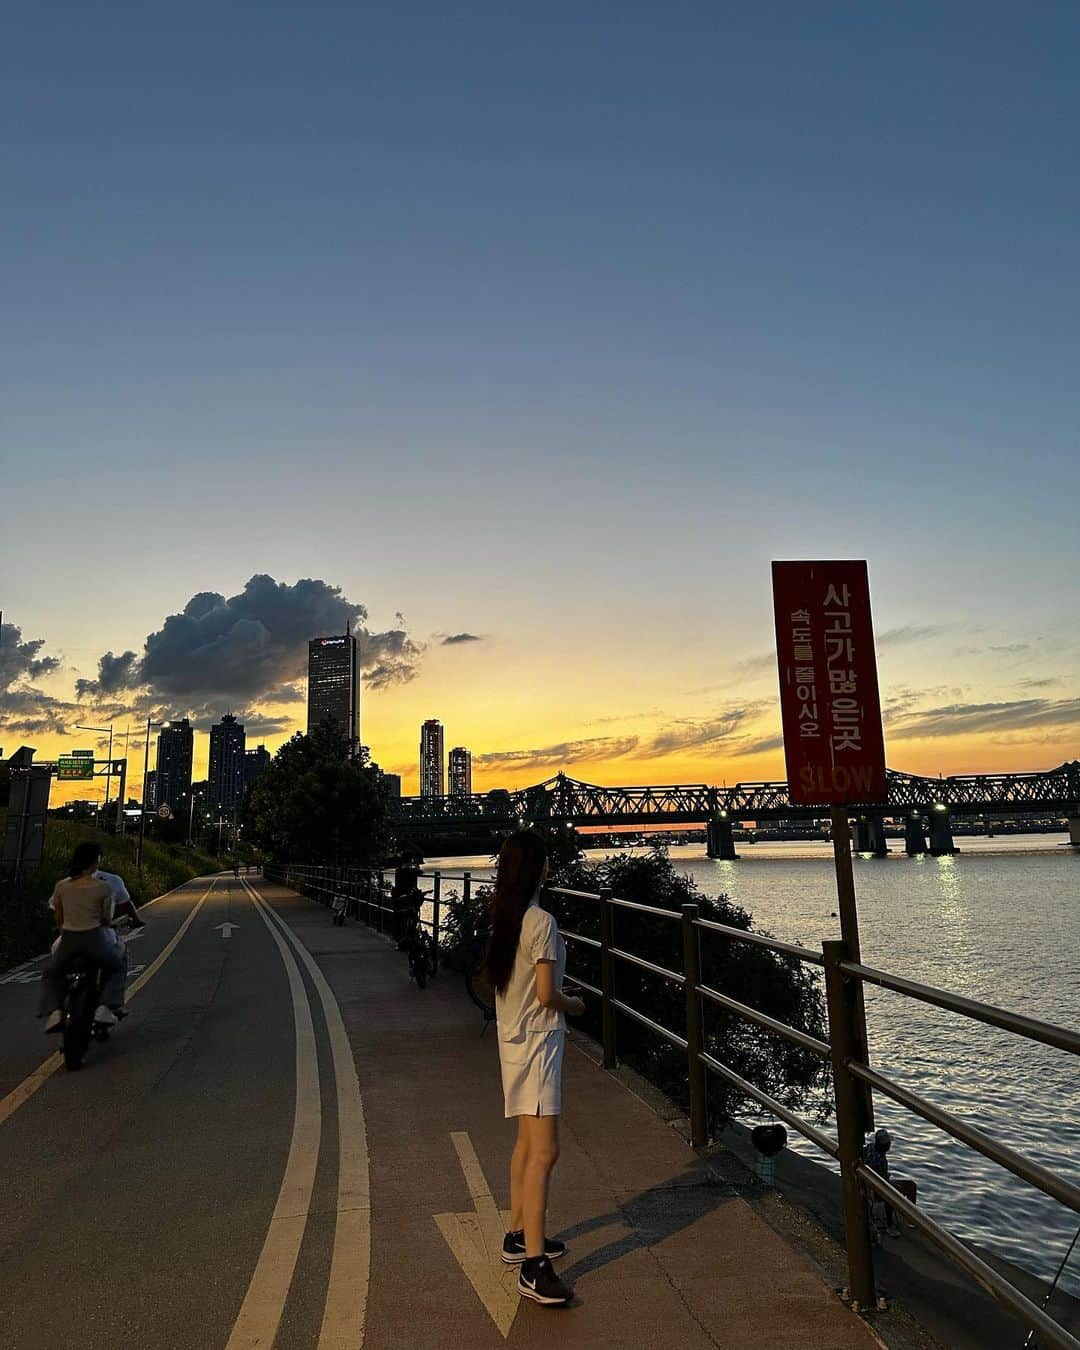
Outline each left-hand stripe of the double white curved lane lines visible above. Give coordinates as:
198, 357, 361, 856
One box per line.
225, 900, 323, 1350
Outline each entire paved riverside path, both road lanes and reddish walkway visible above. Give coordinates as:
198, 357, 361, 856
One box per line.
0, 878, 879, 1350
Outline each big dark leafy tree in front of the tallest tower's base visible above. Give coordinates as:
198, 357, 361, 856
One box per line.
243, 721, 390, 867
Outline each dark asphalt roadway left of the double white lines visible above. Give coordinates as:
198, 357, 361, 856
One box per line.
0, 879, 307, 1350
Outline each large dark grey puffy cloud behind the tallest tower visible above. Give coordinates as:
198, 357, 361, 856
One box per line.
76, 574, 424, 711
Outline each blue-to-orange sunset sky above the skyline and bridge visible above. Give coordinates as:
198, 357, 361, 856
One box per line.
0, 0, 1080, 791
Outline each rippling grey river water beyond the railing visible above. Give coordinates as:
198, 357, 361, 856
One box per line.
425, 834, 1080, 1295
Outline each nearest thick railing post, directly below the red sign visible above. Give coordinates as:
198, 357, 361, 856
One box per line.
822, 942, 878, 1310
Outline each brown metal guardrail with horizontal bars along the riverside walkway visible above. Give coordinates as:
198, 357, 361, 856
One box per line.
266, 867, 1080, 1350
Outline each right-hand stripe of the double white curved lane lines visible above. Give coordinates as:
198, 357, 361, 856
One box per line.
244, 883, 371, 1350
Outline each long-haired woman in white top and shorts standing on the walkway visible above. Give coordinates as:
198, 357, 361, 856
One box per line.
487, 830, 585, 1307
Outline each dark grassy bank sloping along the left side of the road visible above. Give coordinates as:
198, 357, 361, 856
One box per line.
0, 811, 232, 971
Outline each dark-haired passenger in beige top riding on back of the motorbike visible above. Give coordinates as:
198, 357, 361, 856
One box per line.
38, 842, 124, 1031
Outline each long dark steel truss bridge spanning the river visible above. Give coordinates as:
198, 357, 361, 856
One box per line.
392, 760, 1080, 834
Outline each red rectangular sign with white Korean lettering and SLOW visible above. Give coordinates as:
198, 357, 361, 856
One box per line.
772, 562, 886, 806
